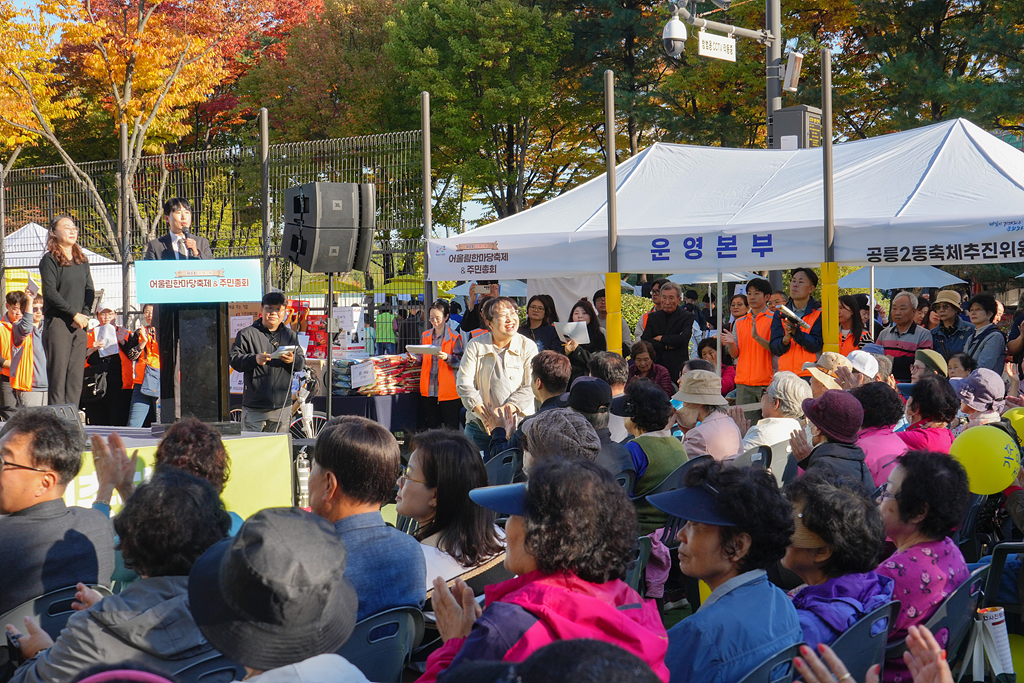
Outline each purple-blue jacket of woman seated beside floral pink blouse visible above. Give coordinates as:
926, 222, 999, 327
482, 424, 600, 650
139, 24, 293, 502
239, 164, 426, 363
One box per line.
793, 571, 895, 647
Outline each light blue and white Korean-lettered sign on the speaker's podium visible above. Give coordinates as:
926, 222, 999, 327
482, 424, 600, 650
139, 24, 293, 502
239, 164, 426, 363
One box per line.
135, 258, 263, 305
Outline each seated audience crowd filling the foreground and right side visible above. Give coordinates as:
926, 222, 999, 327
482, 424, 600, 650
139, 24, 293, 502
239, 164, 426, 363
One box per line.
0, 268, 1024, 683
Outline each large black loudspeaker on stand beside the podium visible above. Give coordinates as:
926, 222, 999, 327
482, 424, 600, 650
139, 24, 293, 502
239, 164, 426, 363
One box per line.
281, 182, 377, 272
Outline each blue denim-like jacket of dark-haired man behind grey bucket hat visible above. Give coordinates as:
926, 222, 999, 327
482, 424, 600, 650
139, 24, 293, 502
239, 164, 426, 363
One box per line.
334, 512, 427, 621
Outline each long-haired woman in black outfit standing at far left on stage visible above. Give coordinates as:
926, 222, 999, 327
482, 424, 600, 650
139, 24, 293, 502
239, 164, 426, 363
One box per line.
39, 216, 95, 405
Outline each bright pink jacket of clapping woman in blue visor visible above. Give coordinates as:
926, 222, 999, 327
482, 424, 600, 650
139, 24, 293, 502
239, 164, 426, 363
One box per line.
417, 571, 669, 683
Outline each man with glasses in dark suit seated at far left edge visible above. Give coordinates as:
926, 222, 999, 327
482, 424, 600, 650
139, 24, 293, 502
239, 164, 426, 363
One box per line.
0, 408, 114, 613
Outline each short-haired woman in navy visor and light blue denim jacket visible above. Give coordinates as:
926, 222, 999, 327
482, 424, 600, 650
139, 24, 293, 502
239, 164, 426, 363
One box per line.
650, 461, 804, 683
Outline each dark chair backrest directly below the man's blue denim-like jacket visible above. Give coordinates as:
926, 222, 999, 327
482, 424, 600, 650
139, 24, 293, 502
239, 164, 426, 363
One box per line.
338, 607, 423, 683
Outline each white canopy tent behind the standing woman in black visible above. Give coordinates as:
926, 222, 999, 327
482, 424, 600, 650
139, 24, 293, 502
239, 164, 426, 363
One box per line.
3, 223, 135, 314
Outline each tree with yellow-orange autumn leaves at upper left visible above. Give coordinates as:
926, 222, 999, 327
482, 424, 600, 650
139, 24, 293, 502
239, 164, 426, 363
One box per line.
0, 0, 268, 258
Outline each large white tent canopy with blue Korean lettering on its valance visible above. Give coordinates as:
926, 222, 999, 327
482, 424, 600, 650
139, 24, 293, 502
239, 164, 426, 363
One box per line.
428, 119, 1024, 280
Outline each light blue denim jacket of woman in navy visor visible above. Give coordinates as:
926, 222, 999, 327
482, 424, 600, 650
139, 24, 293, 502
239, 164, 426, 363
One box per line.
665, 569, 804, 683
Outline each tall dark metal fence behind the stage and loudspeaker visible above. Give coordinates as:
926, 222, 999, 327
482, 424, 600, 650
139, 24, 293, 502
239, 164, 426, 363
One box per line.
3, 131, 423, 315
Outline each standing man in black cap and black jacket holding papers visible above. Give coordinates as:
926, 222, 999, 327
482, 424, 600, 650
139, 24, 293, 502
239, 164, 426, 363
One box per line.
230, 292, 305, 432
